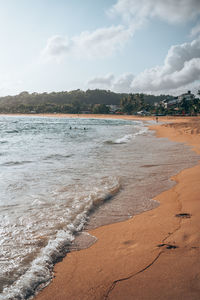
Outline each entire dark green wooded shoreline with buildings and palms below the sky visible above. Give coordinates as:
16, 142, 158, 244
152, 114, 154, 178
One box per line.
0, 89, 200, 115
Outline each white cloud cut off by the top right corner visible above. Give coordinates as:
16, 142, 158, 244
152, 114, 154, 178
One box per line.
110, 0, 200, 23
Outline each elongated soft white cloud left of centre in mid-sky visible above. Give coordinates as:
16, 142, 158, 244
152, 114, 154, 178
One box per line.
42, 25, 133, 59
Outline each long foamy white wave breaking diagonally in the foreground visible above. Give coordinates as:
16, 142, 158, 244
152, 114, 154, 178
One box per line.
0, 177, 121, 300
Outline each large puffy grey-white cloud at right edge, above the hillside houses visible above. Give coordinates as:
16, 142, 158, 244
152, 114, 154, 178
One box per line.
131, 38, 200, 92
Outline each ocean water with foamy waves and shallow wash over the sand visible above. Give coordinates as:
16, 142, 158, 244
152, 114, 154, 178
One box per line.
0, 116, 198, 300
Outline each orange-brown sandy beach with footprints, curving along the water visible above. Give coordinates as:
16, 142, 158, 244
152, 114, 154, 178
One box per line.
32, 115, 200, 300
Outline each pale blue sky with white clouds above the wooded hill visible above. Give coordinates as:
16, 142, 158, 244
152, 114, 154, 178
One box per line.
0, 0, 200, 96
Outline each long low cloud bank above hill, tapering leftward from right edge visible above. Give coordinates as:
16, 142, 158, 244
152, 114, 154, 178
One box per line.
89, 38, 200, 94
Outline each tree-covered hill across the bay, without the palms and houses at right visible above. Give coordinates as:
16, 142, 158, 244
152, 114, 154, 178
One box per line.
0, 89, 170, 113
